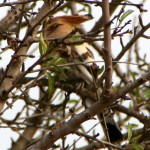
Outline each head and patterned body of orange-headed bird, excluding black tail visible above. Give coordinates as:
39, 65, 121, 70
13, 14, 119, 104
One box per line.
44, 15, 98, 84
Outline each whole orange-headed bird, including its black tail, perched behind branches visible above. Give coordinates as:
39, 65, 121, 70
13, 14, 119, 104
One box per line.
43, 14, 122, 142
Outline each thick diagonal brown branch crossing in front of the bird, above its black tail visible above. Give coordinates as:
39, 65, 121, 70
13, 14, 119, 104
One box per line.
27, 72, 150, 150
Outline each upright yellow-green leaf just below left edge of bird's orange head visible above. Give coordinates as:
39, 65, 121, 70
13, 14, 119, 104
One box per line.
39, 33, 48, 54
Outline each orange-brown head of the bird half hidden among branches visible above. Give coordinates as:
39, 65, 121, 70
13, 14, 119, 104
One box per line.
44, 15, 93, 39
